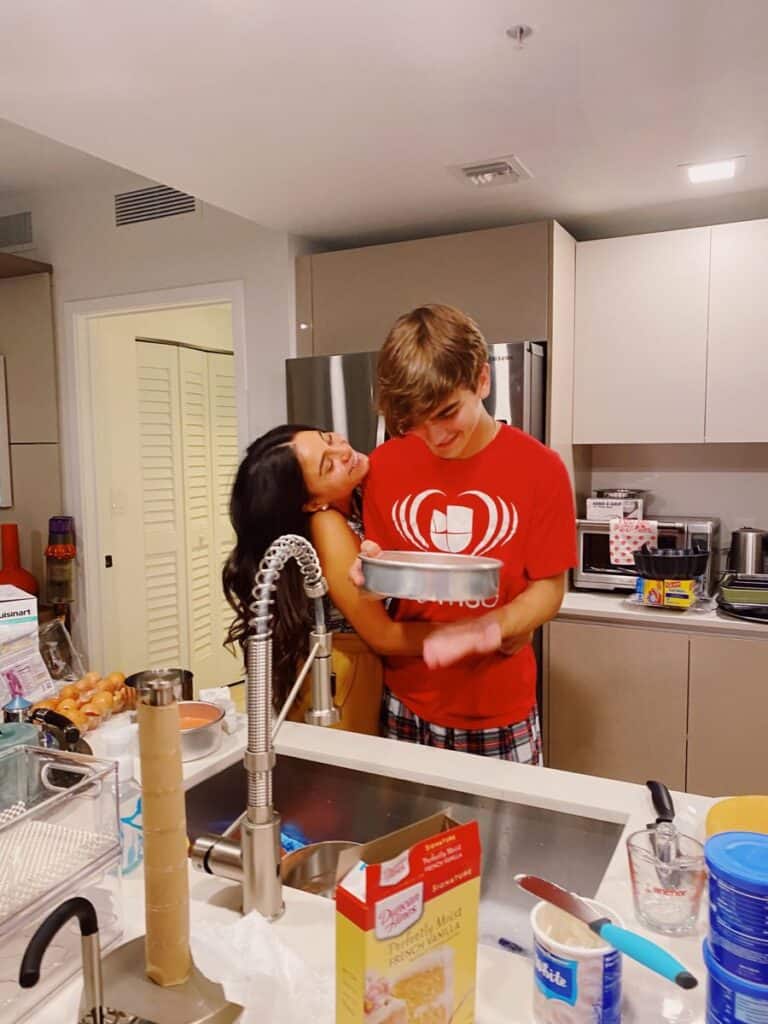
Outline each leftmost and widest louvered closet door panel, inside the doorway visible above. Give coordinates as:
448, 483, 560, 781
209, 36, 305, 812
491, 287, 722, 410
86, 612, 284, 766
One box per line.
135, 342, 188, 669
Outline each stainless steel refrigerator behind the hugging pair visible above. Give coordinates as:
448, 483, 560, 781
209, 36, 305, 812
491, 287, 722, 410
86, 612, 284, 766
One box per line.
286, 341, 547, 452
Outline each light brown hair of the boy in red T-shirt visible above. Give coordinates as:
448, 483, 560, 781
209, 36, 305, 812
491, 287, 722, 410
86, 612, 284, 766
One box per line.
377, 304, 488, 437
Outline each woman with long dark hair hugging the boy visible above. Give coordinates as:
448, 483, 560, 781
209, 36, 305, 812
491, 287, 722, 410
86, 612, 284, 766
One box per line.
222, 424, 434, 733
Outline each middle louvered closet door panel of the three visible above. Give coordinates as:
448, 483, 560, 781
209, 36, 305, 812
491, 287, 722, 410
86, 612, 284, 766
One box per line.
178, 348, 221, 689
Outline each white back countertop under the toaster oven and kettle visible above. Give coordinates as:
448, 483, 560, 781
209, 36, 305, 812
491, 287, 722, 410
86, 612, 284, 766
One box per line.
557, 590, 768, 640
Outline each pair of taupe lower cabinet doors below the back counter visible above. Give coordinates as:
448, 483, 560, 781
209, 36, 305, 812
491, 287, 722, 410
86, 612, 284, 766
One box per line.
544, 620, 768, 797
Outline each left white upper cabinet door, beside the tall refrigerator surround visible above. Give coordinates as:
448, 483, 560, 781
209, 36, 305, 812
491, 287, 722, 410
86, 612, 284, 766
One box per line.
573, 227, 712, 444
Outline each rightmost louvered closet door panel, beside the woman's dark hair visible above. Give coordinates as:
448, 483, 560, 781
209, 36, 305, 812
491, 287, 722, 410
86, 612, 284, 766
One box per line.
207, 352, 243, 685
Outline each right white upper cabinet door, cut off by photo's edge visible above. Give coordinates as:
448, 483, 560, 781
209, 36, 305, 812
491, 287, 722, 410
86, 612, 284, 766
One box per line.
706, 220, 768, 441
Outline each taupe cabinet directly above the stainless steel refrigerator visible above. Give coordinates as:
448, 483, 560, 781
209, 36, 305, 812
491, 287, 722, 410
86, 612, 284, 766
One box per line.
296, 221, 552, 355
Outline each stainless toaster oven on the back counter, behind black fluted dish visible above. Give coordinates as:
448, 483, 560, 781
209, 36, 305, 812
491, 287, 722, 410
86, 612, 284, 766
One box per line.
573, 516, 720, 594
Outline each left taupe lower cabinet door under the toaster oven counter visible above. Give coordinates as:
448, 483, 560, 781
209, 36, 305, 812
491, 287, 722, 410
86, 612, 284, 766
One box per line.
545, 621, 692, 790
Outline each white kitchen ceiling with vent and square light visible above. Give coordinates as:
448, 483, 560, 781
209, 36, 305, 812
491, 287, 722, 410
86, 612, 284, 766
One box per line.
0, 0, 768, 246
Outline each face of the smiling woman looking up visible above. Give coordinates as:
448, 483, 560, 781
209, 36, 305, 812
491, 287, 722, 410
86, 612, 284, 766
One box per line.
293, 430, 368, 512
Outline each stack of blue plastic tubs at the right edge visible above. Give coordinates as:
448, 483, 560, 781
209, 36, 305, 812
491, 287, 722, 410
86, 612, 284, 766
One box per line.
703, 831, 768, 1024
